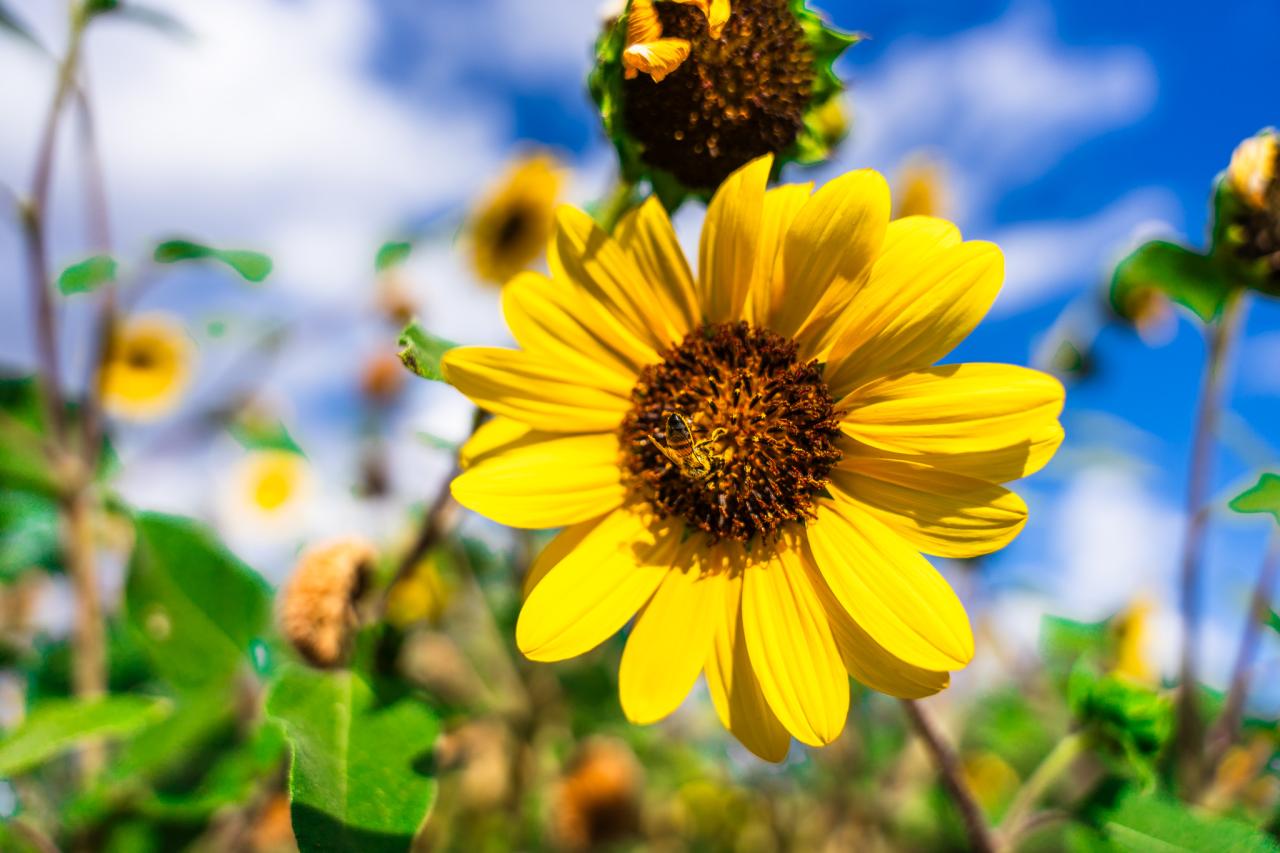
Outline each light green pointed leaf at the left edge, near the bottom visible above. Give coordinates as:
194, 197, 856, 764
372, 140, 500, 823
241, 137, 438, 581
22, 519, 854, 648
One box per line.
0, 695, 170, 777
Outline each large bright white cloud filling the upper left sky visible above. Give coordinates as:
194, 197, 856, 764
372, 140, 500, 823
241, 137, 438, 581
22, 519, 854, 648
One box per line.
0, 0, 504, 306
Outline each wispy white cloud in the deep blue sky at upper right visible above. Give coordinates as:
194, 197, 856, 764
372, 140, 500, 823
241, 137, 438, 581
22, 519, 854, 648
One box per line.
831, 4, 1179, 314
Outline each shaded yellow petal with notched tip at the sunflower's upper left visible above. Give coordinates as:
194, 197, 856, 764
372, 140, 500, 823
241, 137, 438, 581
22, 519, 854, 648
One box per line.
552, 205, 682, 350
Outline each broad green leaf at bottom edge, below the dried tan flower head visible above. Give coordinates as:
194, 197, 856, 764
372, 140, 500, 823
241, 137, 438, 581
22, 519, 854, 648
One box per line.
266, 665, 439, 853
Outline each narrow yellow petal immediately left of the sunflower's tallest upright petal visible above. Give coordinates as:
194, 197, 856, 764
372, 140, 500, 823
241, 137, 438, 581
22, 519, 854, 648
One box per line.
613, 196, 701, 334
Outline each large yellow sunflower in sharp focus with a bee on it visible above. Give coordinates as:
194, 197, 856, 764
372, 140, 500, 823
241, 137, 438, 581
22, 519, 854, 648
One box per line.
443, 156, 1064, 761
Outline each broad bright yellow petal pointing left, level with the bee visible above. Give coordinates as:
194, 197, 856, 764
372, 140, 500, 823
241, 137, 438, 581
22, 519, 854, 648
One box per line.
451, 433, 626, 530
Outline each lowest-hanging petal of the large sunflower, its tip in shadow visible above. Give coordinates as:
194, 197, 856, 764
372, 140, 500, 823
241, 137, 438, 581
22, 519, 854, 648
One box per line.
707, 560, 791, 762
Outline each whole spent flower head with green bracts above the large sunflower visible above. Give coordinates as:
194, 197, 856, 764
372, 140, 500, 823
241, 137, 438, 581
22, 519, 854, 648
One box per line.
590, 0, 859, 209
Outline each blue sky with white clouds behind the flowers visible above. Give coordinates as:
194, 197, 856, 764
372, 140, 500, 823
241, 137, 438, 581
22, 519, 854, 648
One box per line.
0, 0, 1280, 691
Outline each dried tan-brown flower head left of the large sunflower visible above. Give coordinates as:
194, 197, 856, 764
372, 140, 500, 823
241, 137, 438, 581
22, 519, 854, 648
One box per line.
280, 538, 378, 667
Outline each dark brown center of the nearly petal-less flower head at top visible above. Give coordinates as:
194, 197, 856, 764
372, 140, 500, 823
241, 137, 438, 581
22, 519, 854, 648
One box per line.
622, 0, 814, 190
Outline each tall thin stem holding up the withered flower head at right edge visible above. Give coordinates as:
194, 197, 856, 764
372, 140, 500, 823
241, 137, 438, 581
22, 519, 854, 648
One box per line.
1174, 291, 1247, 788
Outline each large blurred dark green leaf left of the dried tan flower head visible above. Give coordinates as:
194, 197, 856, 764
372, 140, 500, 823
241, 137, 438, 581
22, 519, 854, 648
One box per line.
124, 512, 270, 690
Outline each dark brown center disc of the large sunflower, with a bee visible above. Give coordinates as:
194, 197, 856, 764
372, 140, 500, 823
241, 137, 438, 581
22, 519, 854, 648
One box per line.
621, 323, 841, 542
